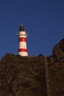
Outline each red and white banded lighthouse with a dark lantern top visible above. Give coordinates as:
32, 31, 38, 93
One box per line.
17, 25, 28, 56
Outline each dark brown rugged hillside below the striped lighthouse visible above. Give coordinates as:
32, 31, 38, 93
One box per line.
0, 39, 64, 96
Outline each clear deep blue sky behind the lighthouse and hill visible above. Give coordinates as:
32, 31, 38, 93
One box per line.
0, 0, 64, 58
